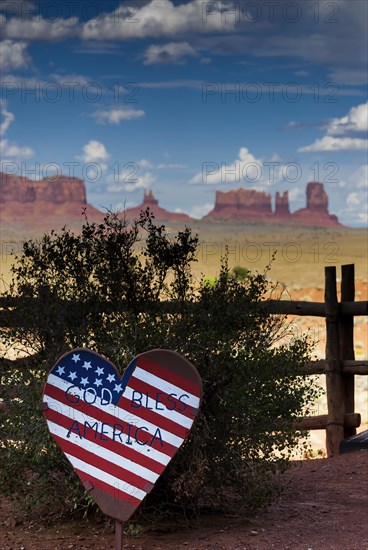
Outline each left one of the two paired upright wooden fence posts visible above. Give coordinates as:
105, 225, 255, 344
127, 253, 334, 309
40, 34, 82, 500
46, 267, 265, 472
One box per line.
325, 267, 345, 457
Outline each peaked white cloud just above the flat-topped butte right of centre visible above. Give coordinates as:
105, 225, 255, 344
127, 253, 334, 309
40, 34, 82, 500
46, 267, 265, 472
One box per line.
190, 147, 284, 187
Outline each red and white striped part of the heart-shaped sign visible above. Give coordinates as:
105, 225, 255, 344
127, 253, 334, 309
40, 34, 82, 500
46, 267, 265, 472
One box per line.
44, 357, 200, 505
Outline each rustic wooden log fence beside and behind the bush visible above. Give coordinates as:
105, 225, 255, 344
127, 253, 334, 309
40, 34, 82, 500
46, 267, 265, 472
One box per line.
0, 264, 368, 457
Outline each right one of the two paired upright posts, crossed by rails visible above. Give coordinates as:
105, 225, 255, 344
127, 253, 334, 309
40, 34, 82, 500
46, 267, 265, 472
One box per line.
339, 264, 356, 437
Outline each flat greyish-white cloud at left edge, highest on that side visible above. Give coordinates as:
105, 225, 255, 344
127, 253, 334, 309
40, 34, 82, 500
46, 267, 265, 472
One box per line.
1, 15, 79, 41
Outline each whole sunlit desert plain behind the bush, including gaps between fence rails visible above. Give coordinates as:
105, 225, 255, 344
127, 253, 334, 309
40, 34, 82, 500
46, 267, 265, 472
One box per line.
0, 221, 368, 451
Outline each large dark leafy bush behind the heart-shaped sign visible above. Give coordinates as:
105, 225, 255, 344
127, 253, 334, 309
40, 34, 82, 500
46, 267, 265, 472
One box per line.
0, 212, 317, 511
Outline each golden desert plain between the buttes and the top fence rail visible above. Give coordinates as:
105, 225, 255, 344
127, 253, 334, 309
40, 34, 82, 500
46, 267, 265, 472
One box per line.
0, 220, 368, 288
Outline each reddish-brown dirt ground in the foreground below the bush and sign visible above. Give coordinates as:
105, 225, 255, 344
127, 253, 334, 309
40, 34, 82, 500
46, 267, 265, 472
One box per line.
0, 450, 368, 550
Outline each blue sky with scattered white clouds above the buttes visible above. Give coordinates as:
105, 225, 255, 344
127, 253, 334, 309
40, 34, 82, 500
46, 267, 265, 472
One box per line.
0, 0, 368, 226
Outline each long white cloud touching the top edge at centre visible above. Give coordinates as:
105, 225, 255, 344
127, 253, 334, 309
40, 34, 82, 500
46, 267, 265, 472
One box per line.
82, 0, 236, 40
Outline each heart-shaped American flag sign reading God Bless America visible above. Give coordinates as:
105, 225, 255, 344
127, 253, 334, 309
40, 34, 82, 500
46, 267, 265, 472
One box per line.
42, 348, 202, 521
